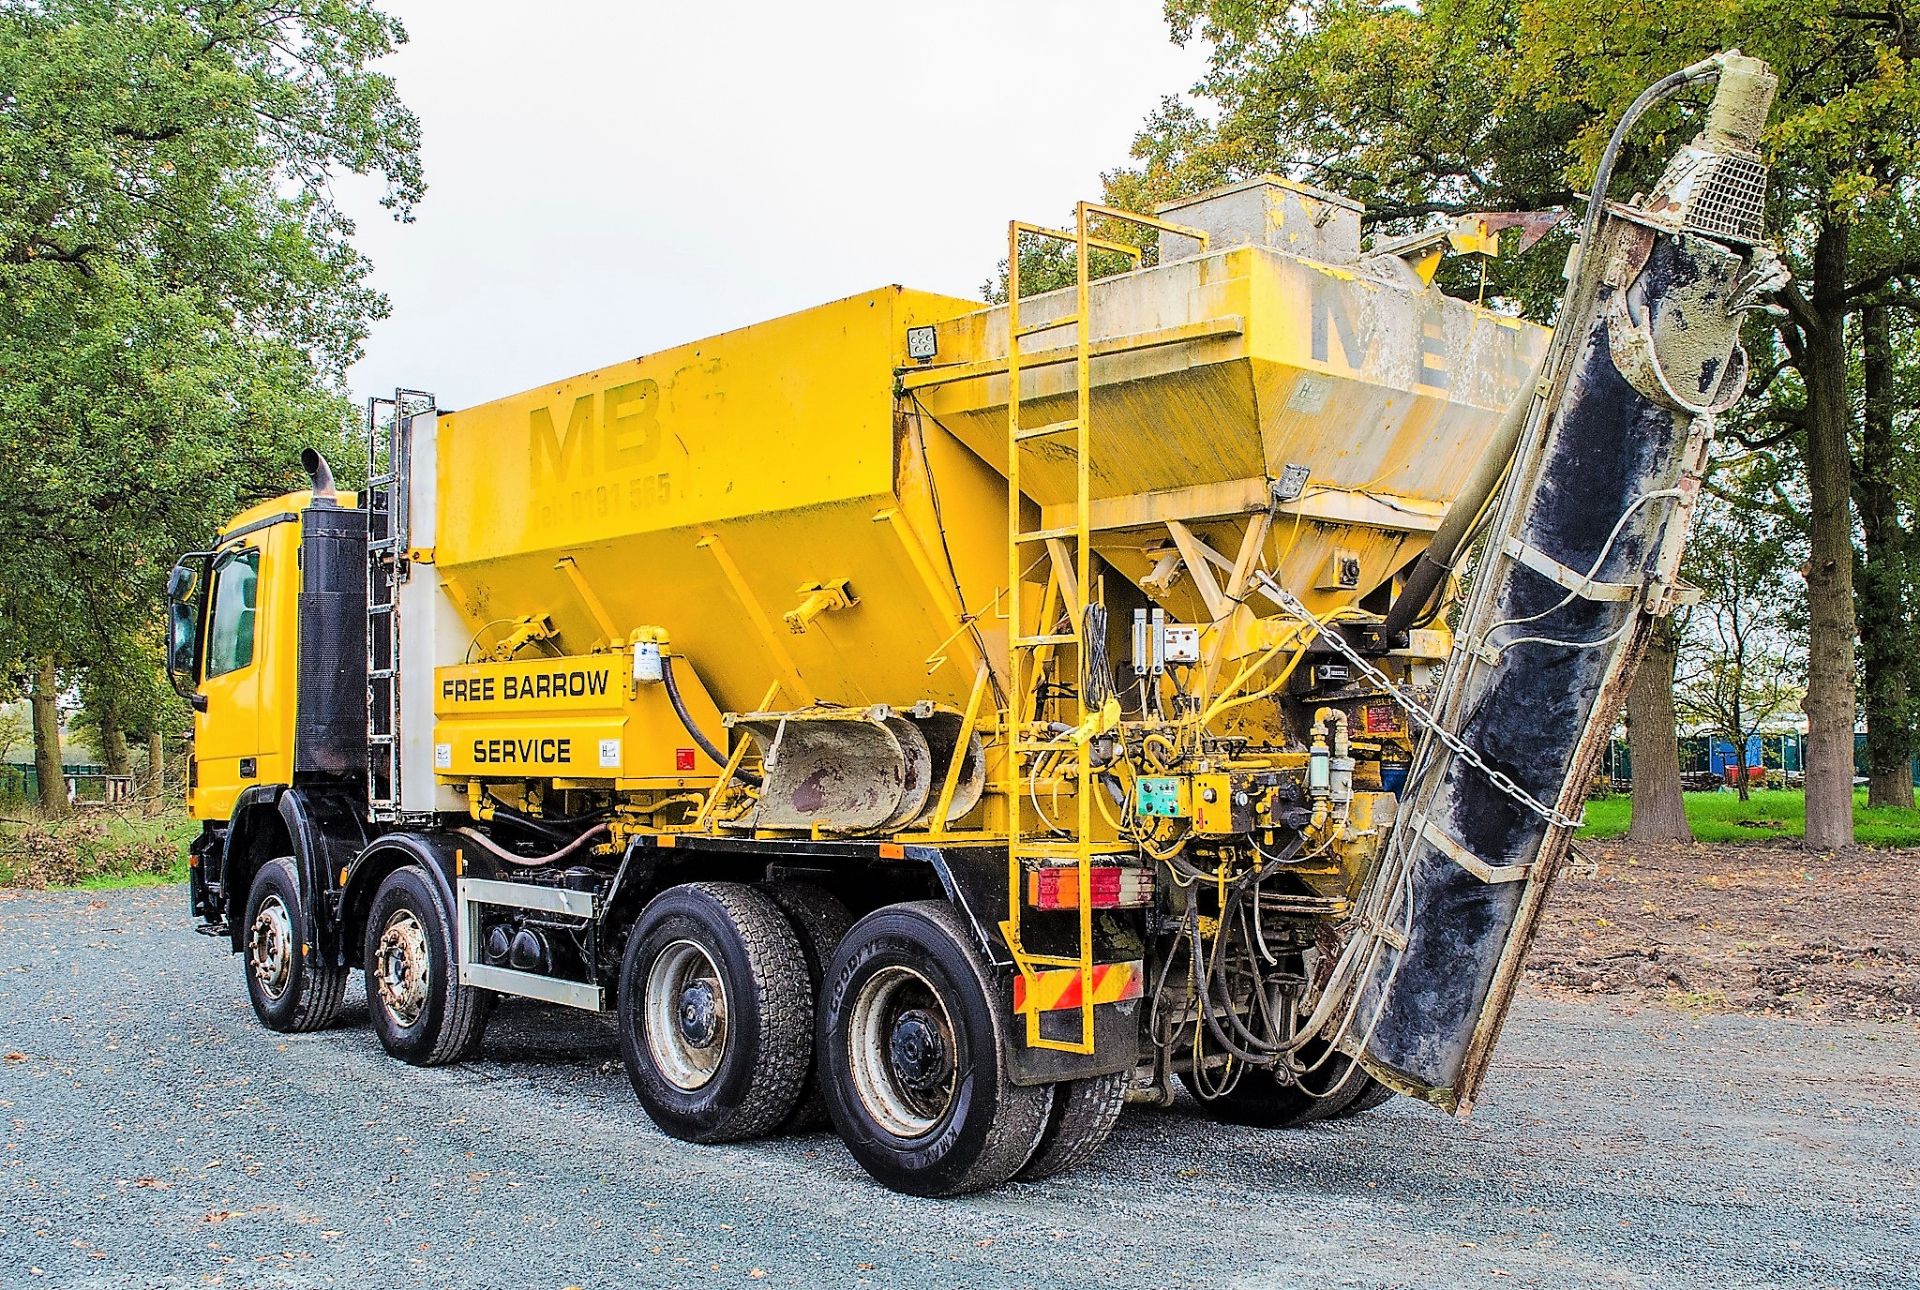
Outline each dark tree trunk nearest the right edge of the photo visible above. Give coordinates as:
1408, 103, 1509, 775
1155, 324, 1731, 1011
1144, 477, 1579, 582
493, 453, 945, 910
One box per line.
1855, 303, 1914, 806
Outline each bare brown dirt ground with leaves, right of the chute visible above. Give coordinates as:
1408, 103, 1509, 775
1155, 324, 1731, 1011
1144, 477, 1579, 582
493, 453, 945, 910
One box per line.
1526, 839, 1920, 1021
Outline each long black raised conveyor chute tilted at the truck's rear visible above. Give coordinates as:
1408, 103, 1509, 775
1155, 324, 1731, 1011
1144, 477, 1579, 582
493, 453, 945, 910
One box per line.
1344, 52, 1784, 1115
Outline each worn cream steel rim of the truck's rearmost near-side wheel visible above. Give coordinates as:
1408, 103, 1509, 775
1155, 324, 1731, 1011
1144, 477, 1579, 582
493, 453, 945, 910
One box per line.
847, 964, 960, 1138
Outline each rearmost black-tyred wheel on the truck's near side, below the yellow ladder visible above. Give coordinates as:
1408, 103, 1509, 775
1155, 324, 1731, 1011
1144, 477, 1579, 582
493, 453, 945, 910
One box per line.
818, 900, 1054, 1196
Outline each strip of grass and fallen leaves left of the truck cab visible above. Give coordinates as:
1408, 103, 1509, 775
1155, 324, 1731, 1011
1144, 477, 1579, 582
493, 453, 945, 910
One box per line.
0, 804, 200, 889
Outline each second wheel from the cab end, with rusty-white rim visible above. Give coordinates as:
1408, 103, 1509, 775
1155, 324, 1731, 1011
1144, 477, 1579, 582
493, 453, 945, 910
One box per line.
361, 864, 492, 1065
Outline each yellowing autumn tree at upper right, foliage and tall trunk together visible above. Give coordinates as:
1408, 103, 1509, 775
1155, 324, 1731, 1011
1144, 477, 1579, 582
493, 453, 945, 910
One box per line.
1108, 0, 1920, 847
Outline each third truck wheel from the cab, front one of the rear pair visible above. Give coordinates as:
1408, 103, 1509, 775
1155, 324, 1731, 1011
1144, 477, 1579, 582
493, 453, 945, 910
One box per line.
620, 883, 814, 1142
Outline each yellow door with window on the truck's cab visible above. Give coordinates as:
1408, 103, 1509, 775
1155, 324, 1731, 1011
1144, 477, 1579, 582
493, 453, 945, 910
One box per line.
192, 541, 267, 820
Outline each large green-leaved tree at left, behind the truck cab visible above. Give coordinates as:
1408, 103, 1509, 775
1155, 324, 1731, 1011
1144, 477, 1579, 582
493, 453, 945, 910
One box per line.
0, 0, 422, 794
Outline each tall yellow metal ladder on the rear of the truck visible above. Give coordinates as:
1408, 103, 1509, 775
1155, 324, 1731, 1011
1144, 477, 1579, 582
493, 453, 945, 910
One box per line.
1000, 202, 1208, 1054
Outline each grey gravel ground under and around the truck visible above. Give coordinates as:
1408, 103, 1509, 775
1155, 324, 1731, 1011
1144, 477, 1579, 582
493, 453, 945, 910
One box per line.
0, 889, 1920, 1290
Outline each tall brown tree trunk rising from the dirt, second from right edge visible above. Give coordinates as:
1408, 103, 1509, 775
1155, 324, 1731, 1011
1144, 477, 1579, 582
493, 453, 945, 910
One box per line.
1801, 221, 1855, 850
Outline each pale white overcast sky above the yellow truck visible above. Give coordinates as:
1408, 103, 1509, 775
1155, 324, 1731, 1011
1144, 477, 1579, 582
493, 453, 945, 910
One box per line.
346, 0, 1202, 407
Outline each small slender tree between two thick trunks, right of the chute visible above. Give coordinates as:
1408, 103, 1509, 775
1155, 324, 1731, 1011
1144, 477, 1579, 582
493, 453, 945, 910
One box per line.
1674, 507, 1807, 800
